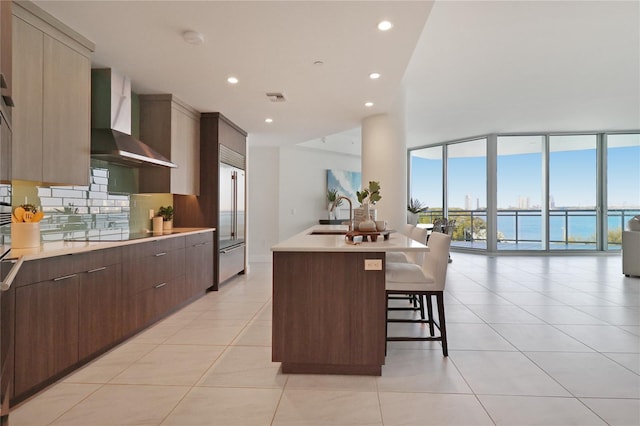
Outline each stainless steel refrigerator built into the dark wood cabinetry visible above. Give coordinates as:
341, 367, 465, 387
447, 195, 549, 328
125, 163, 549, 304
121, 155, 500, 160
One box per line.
218, 163, 245, 282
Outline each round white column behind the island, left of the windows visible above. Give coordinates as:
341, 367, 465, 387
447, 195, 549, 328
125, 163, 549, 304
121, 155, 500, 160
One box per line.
362, 101, 407, 229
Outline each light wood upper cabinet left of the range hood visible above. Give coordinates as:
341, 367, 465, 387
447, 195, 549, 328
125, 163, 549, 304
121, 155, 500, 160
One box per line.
12, 3, 93, 185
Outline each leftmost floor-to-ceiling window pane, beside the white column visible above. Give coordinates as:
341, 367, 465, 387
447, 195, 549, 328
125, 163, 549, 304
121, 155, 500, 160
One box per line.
409, 146, 444, 223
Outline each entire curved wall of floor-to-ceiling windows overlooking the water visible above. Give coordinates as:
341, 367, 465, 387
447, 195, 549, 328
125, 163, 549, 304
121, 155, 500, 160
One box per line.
409, 131, 640, 252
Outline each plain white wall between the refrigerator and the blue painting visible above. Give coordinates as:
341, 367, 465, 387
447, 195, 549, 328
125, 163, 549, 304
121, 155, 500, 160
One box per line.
247, 146, 361, 262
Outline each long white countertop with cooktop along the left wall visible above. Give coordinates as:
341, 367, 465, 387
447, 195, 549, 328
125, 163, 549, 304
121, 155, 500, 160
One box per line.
2, 228, 215, 261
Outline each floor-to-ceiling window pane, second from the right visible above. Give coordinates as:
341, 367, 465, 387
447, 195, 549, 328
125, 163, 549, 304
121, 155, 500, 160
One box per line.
548, 135, 598, 250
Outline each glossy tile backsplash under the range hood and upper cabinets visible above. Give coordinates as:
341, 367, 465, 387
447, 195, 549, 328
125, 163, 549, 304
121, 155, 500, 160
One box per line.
12, 167, 173, 241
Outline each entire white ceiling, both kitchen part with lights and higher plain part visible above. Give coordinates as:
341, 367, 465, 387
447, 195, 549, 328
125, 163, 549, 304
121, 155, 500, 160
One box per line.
35, 0, 640, 152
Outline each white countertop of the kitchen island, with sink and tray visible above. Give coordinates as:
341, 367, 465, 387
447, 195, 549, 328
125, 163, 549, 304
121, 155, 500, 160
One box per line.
271, 225, 429, 252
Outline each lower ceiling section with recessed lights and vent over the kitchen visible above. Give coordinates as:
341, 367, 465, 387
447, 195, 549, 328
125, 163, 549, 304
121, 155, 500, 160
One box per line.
36, 1, 432, 150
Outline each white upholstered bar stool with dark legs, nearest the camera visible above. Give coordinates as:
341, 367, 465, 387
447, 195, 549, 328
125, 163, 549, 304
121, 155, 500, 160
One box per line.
385, 233, 451, 356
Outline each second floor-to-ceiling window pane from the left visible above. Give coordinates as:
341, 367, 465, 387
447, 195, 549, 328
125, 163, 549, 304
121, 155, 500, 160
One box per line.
446, 138, 487, 249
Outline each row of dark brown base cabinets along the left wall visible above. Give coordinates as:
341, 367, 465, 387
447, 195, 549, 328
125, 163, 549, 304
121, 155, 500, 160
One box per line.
10, 232, 213, 404
